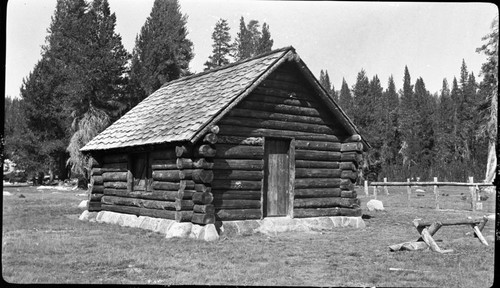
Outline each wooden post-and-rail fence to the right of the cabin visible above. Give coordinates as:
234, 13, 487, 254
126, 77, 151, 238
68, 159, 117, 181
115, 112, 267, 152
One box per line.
364, 177, 494, 211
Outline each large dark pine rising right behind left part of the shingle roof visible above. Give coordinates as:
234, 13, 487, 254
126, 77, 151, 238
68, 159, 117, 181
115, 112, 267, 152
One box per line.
130, 0, 194, 107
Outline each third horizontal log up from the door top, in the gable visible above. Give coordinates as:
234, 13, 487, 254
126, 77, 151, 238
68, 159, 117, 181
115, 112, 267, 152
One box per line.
228, 108, 333, 126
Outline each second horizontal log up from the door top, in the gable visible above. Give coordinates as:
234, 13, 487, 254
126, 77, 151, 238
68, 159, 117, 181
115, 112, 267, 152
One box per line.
220, 117, 341, 135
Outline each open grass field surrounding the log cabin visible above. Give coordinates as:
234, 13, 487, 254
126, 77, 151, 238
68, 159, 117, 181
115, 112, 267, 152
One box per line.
2, 182, 495, 287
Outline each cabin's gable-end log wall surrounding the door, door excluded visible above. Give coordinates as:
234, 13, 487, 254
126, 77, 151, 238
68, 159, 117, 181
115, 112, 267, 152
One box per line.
212, 65, 362, 220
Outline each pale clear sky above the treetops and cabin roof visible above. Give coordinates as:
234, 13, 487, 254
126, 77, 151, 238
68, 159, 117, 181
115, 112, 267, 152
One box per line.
5, 0, 498, 97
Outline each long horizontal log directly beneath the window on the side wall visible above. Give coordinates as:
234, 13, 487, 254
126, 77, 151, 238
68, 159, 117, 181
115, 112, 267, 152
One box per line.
104, 188, 195, 201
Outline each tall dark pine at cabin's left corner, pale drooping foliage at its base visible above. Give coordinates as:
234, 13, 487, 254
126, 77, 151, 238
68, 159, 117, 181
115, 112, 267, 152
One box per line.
62, 0, 129, 179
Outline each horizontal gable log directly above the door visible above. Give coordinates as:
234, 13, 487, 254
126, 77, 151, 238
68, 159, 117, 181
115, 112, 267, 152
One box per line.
220, 125, 339, 141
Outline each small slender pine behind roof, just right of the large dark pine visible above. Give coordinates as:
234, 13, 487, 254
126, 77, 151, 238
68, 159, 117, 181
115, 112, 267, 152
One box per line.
205, 19, 232, 70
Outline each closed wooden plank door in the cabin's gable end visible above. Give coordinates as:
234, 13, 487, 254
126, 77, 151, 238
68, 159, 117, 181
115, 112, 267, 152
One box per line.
264, 138, 290, 216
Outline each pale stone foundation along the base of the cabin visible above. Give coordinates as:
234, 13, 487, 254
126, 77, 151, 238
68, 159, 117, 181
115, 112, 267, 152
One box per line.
79, 210, 365, 241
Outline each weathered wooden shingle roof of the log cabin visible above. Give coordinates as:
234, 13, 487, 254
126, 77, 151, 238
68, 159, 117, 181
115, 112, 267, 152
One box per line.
81, 47, 368, 152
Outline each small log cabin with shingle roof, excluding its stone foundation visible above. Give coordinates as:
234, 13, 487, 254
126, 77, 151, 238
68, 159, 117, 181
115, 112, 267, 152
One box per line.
81, 47, 369, 224
